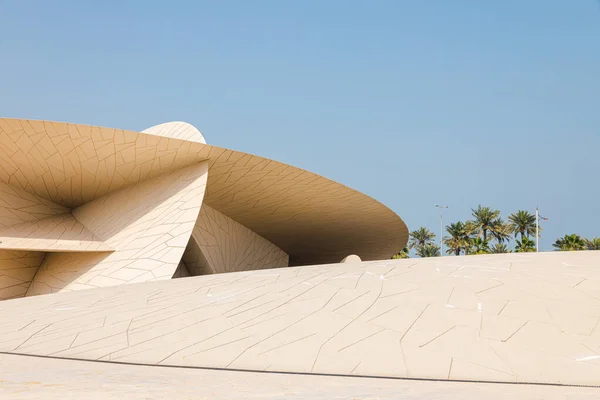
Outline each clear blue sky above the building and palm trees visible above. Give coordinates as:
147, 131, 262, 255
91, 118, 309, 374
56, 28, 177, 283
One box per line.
0, 0, 600, 250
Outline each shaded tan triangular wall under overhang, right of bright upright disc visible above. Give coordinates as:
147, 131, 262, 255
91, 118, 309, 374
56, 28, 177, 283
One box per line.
184, 205, 289, 276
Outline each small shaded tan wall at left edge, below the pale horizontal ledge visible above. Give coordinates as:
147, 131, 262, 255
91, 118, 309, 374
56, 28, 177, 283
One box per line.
0, 250, 46, 300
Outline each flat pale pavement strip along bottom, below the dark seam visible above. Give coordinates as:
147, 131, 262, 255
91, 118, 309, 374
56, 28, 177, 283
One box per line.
0, 355, 600, 400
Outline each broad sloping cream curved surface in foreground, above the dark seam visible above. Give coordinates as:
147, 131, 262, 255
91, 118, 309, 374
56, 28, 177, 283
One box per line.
0, 252, 600, 385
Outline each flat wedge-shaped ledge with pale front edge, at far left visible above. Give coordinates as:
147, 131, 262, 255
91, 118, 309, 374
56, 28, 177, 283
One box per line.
0, 213, 113, 252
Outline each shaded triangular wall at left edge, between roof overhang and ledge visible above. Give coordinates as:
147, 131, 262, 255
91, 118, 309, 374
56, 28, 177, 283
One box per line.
0, 181, 69, 228
